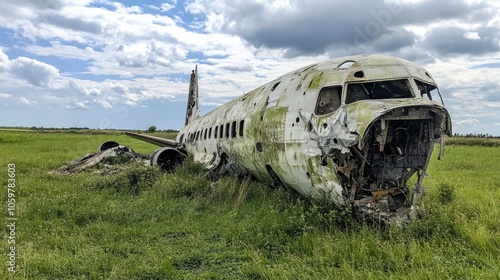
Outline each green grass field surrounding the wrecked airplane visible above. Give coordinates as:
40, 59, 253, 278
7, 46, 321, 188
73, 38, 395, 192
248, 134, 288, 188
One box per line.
0, 131, 500, 279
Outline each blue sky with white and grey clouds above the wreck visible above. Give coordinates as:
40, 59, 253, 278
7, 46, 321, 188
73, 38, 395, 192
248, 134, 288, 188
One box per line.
0, 0, 500, 136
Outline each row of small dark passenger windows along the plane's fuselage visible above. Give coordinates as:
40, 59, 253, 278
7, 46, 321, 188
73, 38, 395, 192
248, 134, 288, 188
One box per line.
184, 120, 245, 142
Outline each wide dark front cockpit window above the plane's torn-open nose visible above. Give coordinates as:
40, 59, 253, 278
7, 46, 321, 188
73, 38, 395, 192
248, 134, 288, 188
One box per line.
345, 80, 413, 104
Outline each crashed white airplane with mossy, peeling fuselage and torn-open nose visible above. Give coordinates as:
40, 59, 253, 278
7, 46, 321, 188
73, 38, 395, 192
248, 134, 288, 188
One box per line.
83, 55, 452, 225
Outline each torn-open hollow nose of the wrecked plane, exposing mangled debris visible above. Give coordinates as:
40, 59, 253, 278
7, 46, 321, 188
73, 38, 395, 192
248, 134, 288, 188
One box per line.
329, 100, 450, 223
